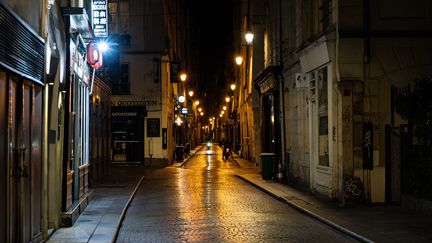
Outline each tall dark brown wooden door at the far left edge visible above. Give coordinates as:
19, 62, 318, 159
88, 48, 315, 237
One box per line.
8, 78, 42, 242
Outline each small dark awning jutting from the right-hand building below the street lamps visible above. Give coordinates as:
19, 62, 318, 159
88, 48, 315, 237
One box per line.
253, 65, 281, 95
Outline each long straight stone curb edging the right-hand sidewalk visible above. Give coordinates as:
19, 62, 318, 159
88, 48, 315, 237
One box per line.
236, 175, 374, 243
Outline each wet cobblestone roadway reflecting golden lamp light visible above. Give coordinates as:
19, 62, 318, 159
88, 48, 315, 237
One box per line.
117, 146, 353, 242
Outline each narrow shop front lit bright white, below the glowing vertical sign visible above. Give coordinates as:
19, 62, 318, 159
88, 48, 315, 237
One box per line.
61, 8, 93, 226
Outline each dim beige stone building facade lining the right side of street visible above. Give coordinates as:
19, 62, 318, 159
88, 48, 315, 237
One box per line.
239, 0, 431, 203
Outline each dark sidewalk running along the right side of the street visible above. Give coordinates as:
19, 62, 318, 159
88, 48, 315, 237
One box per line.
234, 155, 432, 242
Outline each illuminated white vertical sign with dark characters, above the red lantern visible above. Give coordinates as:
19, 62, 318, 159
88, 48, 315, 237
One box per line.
92, 0, 108, 37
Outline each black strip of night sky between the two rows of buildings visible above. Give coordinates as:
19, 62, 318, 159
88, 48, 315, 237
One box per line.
189, 0, 233, 119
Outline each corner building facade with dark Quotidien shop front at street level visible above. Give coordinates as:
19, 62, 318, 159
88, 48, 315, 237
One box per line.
109, 0, 174, 165
